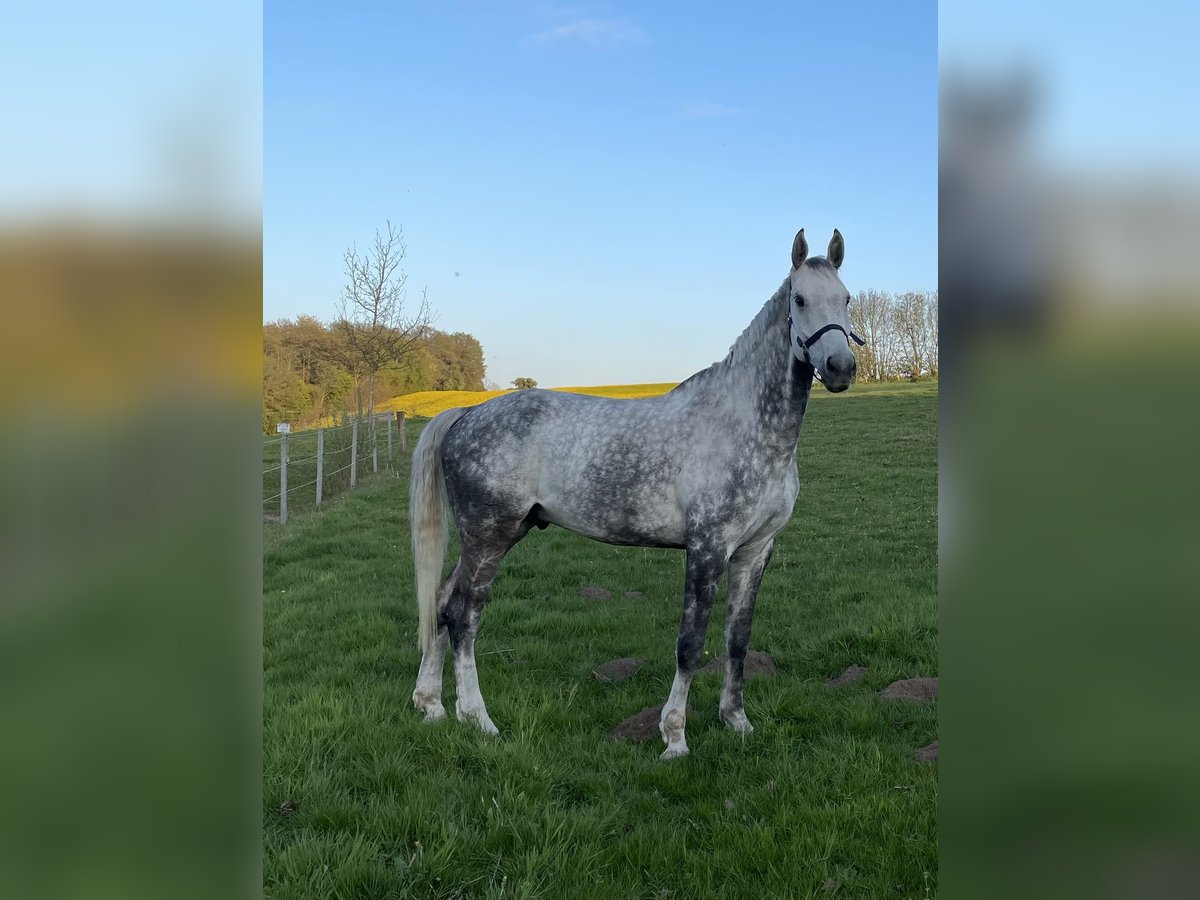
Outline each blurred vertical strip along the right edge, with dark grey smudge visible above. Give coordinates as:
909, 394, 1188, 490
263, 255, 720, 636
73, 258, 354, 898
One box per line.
938, 2, 1200, 898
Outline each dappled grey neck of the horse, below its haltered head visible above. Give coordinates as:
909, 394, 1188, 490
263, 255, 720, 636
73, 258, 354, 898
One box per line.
718, 280, 812, 454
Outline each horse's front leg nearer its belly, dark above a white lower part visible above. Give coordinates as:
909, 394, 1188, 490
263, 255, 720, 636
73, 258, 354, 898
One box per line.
659, 547, 727, 760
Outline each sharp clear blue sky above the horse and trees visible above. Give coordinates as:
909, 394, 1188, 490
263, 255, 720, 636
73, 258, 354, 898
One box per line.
263, 0, 937, 386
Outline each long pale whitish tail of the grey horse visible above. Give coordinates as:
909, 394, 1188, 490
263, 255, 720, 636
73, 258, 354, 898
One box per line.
408, 408, 467, 653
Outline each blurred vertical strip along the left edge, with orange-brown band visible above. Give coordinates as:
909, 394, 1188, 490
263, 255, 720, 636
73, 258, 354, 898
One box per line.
0, 0, 262, 898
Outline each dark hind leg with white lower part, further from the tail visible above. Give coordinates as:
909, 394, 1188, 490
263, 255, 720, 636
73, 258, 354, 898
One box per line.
438, 527, 528, 734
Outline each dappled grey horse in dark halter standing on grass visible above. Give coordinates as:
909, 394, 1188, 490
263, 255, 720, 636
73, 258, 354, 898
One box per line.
409, 228, 862, 760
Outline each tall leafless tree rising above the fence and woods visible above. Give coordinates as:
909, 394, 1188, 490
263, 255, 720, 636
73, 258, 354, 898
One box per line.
336, 222, 433, 415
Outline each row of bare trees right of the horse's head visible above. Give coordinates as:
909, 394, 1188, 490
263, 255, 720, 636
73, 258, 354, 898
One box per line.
850, 290, 937, 382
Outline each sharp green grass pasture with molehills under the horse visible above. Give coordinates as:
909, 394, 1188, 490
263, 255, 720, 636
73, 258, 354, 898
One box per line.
263, 384, 937, 900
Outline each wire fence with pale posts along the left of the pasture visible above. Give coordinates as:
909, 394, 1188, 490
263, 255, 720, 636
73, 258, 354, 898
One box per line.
263, 413, 408, 524
